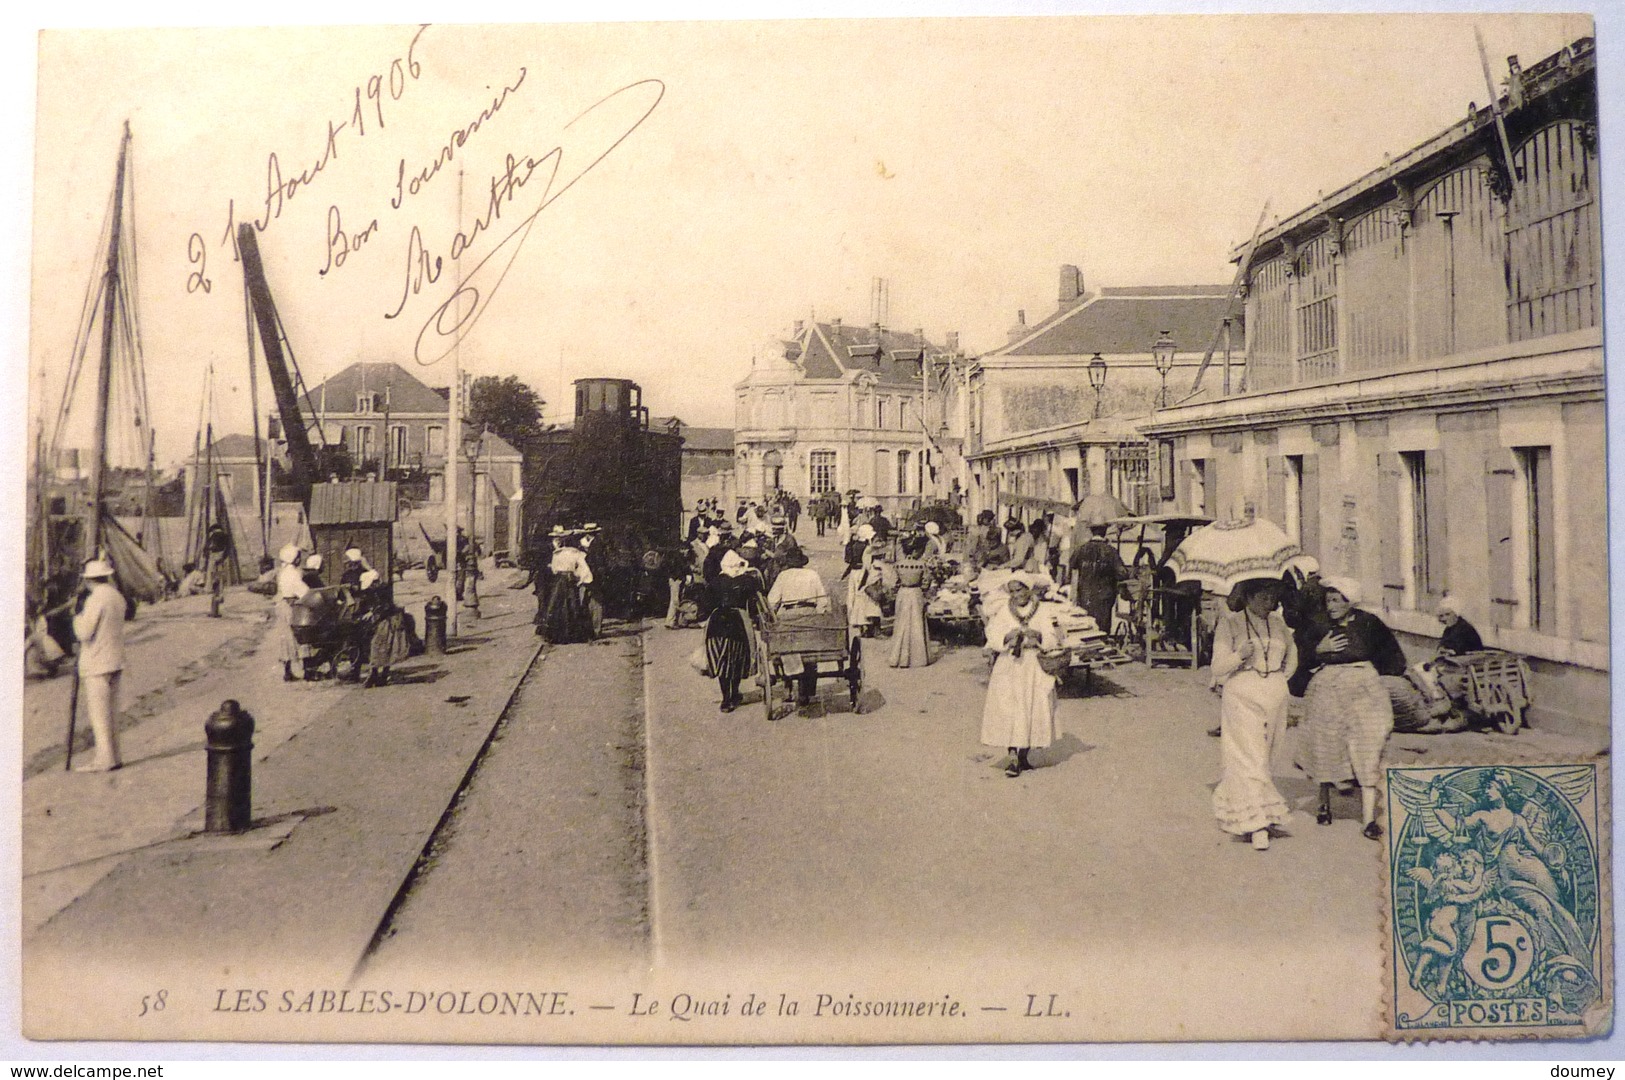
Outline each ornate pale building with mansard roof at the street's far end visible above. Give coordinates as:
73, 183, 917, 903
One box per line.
733, 318, 946, 512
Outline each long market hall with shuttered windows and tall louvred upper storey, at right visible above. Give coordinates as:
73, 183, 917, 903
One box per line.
1142, 37, 1609, 726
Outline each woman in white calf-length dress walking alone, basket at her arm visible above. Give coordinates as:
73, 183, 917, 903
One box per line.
982, 573, 1061, 776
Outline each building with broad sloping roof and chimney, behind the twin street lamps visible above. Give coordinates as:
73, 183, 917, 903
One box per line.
962, 266, 1245, 518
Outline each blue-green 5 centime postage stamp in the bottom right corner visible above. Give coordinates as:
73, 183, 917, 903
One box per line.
1388, 763, 1614, 1039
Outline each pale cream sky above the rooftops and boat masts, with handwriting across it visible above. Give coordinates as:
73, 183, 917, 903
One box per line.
19, 15, 1591, 466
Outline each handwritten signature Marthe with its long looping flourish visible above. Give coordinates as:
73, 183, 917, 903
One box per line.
385, 78, 666, 364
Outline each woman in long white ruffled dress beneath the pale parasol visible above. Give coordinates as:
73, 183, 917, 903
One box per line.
1212, 581, 1298, 851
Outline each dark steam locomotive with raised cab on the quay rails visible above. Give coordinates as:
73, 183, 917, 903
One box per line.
520, 378, 683, 617
